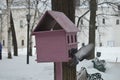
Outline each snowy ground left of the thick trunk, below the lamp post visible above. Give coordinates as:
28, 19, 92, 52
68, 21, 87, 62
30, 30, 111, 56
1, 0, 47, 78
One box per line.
0, 49, 54, 80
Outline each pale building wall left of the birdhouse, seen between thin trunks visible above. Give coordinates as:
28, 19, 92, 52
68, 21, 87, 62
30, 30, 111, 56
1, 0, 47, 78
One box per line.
1, 8, 38, 48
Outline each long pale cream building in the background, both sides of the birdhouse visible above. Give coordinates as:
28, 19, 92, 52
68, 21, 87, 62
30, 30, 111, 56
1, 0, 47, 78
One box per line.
0, 0, 120, 48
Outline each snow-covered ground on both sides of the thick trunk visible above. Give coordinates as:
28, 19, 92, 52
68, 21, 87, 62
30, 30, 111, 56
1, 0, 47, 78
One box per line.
0, 48, 120, 80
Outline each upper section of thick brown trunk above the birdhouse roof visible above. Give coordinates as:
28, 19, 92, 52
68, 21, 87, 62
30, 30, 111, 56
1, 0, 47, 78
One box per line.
52, 0, 75, 23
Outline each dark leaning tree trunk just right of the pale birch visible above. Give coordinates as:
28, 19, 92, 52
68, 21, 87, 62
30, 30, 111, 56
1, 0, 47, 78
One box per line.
10, 11, 18, 56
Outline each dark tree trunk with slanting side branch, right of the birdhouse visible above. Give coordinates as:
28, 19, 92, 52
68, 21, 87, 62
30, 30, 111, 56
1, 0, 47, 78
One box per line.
77, 0, 97, 59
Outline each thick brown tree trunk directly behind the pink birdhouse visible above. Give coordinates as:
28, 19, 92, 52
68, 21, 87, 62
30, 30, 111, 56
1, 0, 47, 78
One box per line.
52, 0, 76, 80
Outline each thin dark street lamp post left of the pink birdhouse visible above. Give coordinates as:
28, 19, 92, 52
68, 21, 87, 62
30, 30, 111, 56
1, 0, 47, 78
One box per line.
26, 13, 31, 64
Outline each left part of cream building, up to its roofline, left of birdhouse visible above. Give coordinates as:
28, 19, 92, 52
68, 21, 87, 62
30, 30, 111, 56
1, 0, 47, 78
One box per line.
0, 2, 40, 48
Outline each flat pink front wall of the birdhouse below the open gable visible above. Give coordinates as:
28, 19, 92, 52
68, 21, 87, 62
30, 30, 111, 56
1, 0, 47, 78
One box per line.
35, 30, 69, 62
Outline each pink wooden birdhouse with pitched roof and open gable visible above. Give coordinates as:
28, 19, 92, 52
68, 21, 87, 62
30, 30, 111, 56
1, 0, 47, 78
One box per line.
33, 11, 79, 62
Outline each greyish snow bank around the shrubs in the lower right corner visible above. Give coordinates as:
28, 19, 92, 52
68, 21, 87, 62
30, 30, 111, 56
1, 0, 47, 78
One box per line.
77, 60, 120, 80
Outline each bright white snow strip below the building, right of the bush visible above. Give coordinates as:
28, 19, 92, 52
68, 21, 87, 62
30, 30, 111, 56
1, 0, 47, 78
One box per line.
96, 47, 120, 62
